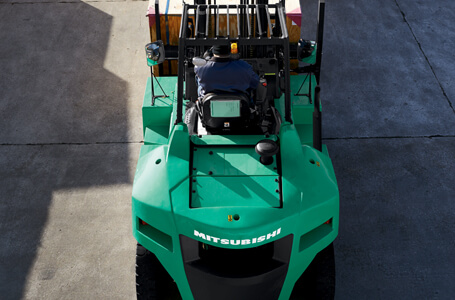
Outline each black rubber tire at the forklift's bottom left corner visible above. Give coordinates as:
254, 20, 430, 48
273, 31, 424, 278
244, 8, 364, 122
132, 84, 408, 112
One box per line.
136, 244, 181, 300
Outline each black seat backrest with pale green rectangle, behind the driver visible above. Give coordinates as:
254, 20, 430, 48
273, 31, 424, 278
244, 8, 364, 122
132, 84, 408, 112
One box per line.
202, 93, 250, 131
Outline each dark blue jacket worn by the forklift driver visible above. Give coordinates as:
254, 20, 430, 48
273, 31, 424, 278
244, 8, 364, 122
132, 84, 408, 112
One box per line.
194, 57, 259, 96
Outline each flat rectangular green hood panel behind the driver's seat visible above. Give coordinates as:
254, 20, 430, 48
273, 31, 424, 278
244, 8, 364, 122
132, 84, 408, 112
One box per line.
190, 146, 281, 208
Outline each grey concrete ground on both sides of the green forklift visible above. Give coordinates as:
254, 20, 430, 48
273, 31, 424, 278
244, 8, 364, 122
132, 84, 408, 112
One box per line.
0, 0, 455, 299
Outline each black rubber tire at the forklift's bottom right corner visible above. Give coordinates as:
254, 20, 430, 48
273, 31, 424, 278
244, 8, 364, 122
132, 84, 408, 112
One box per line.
290, 243, 335, 300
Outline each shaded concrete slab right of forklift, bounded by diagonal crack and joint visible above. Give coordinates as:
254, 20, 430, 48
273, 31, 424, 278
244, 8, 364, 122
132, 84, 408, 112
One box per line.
321, 0, 455, 138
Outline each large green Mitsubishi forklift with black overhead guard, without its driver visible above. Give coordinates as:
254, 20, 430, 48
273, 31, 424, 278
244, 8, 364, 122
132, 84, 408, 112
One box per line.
132, 0, 339, 300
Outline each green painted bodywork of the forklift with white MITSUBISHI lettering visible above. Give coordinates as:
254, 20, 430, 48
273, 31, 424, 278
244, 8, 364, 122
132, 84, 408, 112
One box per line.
132, 76, 339, 299
